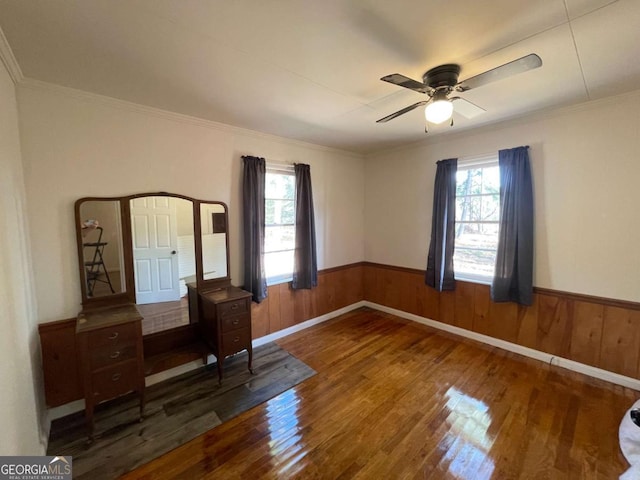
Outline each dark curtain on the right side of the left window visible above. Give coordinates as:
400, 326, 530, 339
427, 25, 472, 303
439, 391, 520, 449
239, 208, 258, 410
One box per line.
291, 163, 318, 289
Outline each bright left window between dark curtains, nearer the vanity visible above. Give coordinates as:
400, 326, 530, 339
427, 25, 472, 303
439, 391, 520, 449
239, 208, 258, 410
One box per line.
264, 166, 296, 284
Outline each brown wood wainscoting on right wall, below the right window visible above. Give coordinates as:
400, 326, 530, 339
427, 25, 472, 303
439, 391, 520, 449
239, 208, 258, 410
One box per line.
362, 262, 640, 378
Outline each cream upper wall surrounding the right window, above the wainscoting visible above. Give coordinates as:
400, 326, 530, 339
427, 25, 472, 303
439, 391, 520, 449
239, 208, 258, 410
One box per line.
365, 92, 640, 301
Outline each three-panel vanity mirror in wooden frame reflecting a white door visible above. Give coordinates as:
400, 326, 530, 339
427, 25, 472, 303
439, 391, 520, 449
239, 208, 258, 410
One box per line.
75, 192, 230, 334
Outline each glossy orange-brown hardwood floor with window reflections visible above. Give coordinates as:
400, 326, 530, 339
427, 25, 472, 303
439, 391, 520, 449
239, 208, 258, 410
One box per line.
124, 309, 640, 480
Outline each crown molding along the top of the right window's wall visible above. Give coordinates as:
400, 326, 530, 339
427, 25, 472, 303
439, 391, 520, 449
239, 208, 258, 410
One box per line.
366, 89, 640, 159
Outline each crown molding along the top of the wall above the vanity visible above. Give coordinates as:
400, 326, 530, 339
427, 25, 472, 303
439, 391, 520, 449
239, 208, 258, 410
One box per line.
19, 77, 364, 159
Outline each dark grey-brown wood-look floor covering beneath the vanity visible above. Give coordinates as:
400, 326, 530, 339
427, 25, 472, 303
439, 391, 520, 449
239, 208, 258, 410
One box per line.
47, 343, 316, 480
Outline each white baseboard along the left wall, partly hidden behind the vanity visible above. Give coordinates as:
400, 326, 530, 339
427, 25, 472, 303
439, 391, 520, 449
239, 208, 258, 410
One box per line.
47, 300, 367, 425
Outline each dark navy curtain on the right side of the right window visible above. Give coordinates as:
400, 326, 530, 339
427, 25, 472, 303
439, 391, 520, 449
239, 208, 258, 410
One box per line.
491, 147, 533, 305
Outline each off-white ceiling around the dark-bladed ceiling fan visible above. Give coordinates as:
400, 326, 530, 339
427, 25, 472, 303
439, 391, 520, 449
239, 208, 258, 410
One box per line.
0, 0, 640, 152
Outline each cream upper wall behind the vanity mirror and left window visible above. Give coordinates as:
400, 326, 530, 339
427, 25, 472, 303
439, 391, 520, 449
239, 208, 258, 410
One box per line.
18, 82, 364, 322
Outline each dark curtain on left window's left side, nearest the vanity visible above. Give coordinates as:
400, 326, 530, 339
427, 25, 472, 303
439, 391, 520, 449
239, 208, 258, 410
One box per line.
242, 156, 267, 303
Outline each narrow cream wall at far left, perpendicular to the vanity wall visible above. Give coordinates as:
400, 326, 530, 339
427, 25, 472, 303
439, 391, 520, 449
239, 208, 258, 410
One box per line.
0, 59, 44, 455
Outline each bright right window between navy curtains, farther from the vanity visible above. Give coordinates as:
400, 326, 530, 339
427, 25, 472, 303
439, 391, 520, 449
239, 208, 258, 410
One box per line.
453, 156, 500, 283
